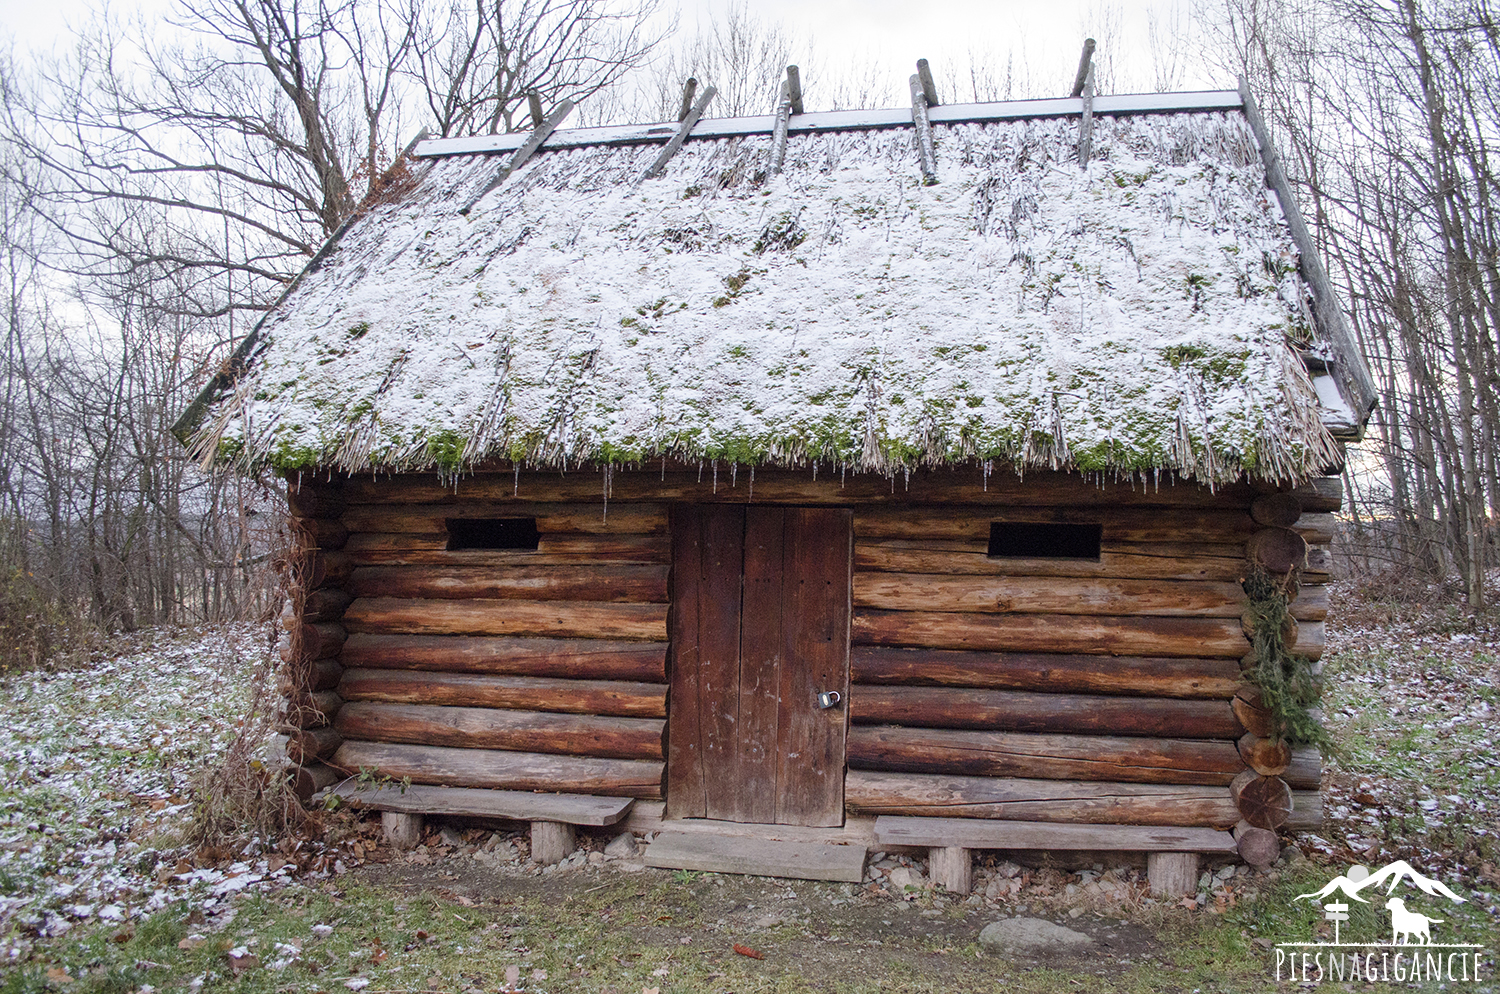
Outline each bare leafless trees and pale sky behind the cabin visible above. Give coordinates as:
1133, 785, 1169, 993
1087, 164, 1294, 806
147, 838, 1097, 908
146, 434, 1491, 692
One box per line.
0, 0, 1500, 672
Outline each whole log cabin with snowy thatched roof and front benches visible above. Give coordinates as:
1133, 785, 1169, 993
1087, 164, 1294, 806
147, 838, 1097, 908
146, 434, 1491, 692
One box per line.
179, 73, 1374, 892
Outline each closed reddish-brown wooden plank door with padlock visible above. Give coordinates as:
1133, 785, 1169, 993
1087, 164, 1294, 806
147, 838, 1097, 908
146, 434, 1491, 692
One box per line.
666, 505, 854, 826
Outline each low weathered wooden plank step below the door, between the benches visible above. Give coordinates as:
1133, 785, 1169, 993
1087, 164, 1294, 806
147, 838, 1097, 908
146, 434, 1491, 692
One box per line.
647, 832, 866, 883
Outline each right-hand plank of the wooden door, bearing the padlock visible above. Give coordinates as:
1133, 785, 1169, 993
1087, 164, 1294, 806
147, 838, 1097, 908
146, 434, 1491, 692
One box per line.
774, 508, 852, 826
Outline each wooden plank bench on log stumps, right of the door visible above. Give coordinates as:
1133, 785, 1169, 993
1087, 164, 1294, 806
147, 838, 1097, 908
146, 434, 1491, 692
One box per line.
875, 814, 1236, 897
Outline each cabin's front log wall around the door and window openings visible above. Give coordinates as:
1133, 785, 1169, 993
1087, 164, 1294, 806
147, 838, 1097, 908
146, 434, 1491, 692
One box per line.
288, 468, 1341, 828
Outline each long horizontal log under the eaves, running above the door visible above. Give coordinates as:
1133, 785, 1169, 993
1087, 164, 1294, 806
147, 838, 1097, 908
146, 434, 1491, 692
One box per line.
344, 466, 1259, 510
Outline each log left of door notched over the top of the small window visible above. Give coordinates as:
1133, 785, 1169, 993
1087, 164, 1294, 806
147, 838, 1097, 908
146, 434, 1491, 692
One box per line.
342, 502, 666, 535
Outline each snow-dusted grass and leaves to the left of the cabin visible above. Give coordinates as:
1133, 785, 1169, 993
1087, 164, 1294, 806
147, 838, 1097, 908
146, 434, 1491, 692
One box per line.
0, 625, 301, 964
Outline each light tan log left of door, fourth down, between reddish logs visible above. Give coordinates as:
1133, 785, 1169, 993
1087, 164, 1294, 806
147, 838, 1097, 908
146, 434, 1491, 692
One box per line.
344, 597, 668, 642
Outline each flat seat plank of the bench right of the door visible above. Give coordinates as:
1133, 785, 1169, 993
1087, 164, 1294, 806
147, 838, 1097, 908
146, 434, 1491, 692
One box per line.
875, 814, 1236, 853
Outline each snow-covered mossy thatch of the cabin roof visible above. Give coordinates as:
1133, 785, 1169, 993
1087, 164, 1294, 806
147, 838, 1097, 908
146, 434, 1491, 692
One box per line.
195, 101, 1338, 483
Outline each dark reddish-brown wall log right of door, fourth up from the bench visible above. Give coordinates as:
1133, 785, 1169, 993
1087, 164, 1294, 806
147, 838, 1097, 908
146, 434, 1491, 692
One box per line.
852, 646, 1241, 700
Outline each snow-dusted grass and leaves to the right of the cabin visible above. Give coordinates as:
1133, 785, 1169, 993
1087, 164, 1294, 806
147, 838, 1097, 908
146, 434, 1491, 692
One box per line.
1311, 595, 1500, 915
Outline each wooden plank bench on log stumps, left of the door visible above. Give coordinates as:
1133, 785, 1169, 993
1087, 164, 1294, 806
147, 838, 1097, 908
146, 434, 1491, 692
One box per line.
326, 783, 635, 864
